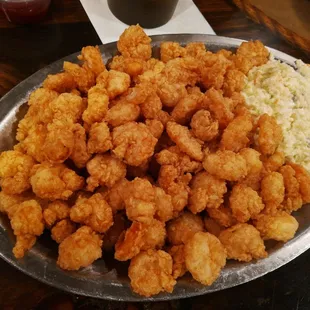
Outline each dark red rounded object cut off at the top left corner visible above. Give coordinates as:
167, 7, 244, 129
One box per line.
0, 0, 51, 24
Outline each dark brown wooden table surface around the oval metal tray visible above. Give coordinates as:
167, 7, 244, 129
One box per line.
0, 0, 310, 310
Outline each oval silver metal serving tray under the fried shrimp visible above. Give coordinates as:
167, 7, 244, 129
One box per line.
0, 34, 310, 301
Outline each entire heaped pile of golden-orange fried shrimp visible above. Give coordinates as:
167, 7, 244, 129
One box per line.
0, 25, 310, 297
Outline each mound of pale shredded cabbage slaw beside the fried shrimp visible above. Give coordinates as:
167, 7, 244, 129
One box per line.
242, 58, 310, 171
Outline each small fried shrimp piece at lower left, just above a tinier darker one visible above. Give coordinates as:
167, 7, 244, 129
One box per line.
43, 200, 70, 227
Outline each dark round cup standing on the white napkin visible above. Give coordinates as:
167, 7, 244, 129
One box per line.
108, 0, 179, 28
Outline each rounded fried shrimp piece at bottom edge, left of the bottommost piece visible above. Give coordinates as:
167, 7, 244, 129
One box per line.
57, 226, 102, 270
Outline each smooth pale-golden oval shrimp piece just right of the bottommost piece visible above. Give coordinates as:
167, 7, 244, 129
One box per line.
184, 232, 226, 285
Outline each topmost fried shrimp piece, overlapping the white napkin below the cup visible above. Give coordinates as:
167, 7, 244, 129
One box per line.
117, 25, 152, 60
